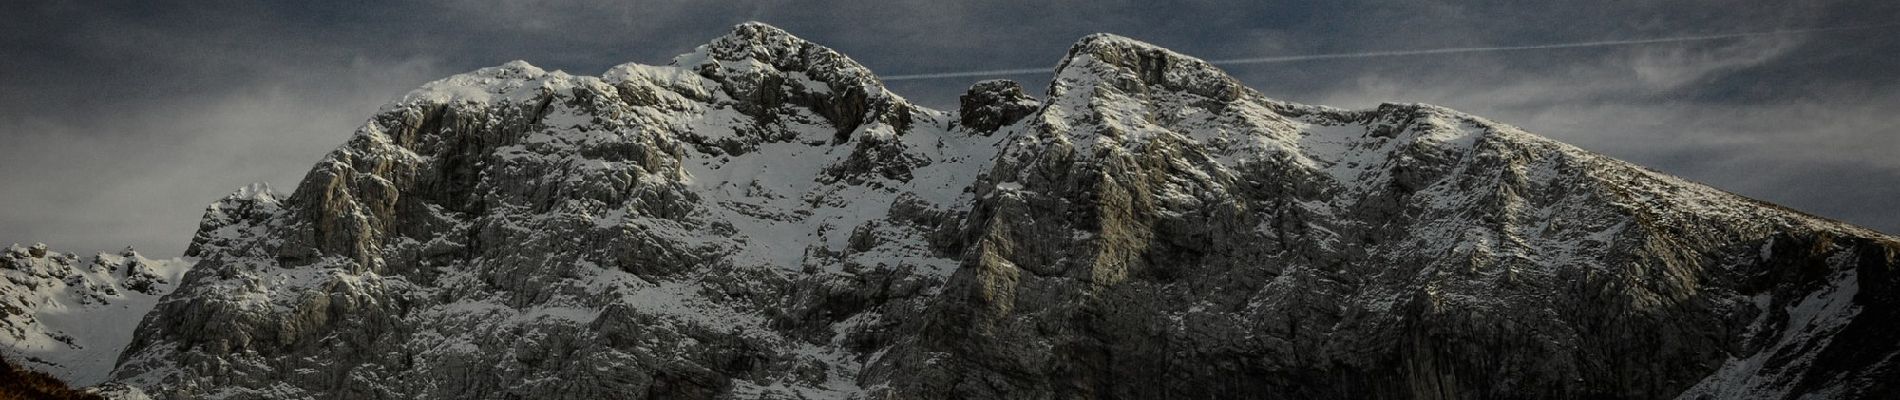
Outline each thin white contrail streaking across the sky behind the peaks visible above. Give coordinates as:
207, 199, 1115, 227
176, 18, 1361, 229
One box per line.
882, 23, 1900, 82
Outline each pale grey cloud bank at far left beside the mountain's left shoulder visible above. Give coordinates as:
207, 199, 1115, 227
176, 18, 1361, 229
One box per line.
0, 54, 437, 256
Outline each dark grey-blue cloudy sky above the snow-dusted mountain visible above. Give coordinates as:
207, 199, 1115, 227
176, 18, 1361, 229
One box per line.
0, 0, 1900, 256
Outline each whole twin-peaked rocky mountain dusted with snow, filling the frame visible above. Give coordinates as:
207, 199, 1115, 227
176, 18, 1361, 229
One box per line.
96, 23, 1900, 398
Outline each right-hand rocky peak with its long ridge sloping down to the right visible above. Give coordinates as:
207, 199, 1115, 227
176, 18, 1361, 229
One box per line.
884, 36, 1896, 398
